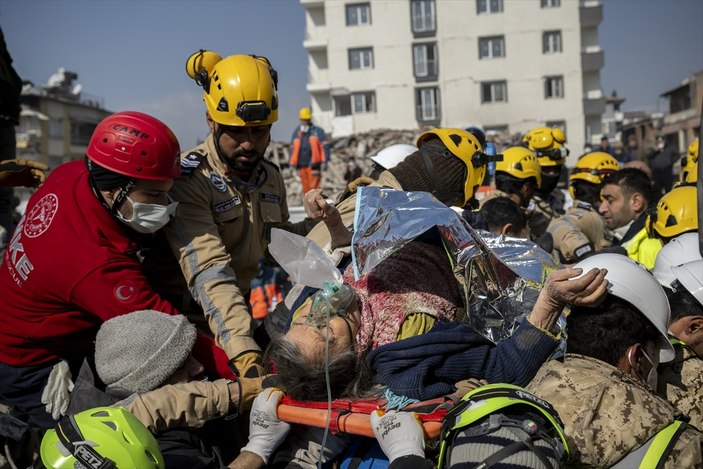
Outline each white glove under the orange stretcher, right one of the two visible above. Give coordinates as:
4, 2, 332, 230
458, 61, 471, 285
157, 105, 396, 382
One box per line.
371, 410, 425, 462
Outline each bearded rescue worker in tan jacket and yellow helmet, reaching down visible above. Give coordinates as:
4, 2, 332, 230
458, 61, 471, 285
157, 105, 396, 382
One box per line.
166, 50, 289, 409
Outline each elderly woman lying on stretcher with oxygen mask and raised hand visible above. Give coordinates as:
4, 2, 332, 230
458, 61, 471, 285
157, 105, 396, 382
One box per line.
266, 225, 607, 401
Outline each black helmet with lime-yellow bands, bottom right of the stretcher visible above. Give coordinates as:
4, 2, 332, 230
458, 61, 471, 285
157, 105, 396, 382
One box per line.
439, 384, 569, 469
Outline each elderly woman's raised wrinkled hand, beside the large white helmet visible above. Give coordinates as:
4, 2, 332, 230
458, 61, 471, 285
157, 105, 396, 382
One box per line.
528, 268, 608, 331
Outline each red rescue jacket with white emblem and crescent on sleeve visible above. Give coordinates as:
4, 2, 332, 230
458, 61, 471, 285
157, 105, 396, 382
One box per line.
0, 161, 178, 366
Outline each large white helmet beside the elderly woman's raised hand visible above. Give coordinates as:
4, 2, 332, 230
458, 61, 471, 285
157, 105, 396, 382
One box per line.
574, 253, 675, 363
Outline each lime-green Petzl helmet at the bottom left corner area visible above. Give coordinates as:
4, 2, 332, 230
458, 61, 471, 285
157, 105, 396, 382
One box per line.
40, 407, 166, 469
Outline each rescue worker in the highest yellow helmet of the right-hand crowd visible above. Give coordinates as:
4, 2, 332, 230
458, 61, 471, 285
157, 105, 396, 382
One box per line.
522, 127, 569, 221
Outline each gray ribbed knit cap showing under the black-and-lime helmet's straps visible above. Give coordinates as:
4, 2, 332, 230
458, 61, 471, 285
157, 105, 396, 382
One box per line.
447, 418, 559, 469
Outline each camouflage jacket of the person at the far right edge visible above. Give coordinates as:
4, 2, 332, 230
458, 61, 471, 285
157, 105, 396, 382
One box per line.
658, 345, 703, 429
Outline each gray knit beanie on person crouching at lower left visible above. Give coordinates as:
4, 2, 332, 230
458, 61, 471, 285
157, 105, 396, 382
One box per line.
95, 310, 196, 393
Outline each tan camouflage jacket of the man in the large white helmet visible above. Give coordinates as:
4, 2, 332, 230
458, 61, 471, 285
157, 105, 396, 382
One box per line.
527, 353, 703, 468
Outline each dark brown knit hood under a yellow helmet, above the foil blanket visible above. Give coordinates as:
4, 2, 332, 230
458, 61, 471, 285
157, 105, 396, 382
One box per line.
388, 139, 466, 204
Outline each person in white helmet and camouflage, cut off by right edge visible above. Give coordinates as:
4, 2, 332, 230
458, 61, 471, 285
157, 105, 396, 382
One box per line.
652, 238, 703, 428
